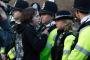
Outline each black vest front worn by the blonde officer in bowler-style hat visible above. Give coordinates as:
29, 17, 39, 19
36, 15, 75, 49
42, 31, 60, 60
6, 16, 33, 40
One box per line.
51, 32, 72, 60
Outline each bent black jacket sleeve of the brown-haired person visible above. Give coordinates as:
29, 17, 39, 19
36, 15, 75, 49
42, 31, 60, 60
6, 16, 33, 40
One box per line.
23, 28, 47, 52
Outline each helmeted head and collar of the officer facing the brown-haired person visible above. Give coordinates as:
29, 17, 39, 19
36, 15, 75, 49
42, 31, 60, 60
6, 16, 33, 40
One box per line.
38, 1, 57, 35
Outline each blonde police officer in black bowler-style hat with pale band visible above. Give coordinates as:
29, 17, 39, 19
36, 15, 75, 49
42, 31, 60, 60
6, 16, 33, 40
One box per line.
51, 10, 75, 60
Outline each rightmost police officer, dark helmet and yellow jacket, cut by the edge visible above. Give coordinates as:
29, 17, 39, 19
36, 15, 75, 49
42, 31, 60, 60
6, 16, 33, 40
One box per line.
68, 0, 90, 60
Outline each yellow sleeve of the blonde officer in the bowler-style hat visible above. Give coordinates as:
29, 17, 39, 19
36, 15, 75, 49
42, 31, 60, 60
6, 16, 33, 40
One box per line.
62, 35, 75, 60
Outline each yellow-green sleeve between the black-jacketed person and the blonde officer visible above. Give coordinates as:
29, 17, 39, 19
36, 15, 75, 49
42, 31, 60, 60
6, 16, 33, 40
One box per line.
40, 29, 57, 60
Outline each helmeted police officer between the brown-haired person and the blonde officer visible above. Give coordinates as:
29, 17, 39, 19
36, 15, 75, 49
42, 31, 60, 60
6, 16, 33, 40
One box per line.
38, 1, 57, 60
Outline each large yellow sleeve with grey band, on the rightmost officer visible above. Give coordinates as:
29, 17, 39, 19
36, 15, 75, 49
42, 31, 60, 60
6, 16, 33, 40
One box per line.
68, 26, 90, 60
